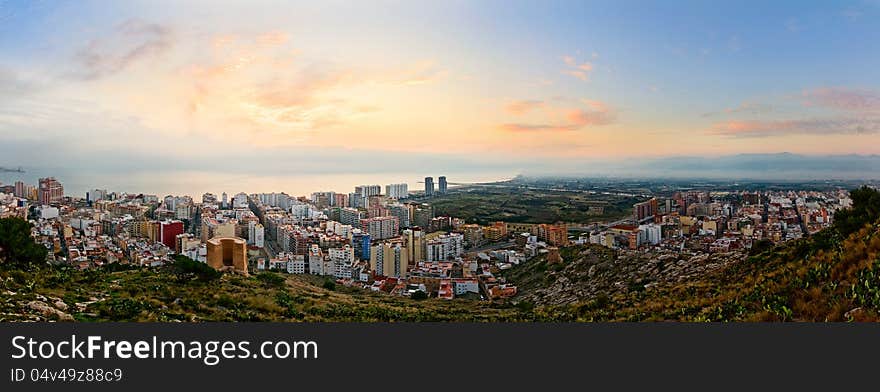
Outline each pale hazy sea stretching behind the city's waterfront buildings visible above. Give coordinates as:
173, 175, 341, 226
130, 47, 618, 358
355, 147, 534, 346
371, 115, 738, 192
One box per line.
0, 168, 515, 199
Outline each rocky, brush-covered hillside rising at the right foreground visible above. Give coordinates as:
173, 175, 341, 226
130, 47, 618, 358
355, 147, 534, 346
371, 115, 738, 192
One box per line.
504, 188, 880, 321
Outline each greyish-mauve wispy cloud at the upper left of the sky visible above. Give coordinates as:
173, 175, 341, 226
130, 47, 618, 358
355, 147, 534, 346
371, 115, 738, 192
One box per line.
72, 19, 174, 80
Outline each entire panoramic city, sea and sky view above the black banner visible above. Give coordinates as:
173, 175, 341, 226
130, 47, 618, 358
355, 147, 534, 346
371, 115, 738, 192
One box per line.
0, 0, 880, 323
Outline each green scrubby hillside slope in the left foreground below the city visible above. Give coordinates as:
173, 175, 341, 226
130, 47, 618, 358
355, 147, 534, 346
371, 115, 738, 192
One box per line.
0, 263, 560, 322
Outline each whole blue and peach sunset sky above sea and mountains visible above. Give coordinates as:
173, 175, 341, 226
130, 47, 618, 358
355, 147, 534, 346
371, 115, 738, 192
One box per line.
0, 0, 880, 178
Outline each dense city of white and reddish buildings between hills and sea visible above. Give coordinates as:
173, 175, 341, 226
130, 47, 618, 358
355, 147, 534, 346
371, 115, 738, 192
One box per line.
0, 176, 868, 301
